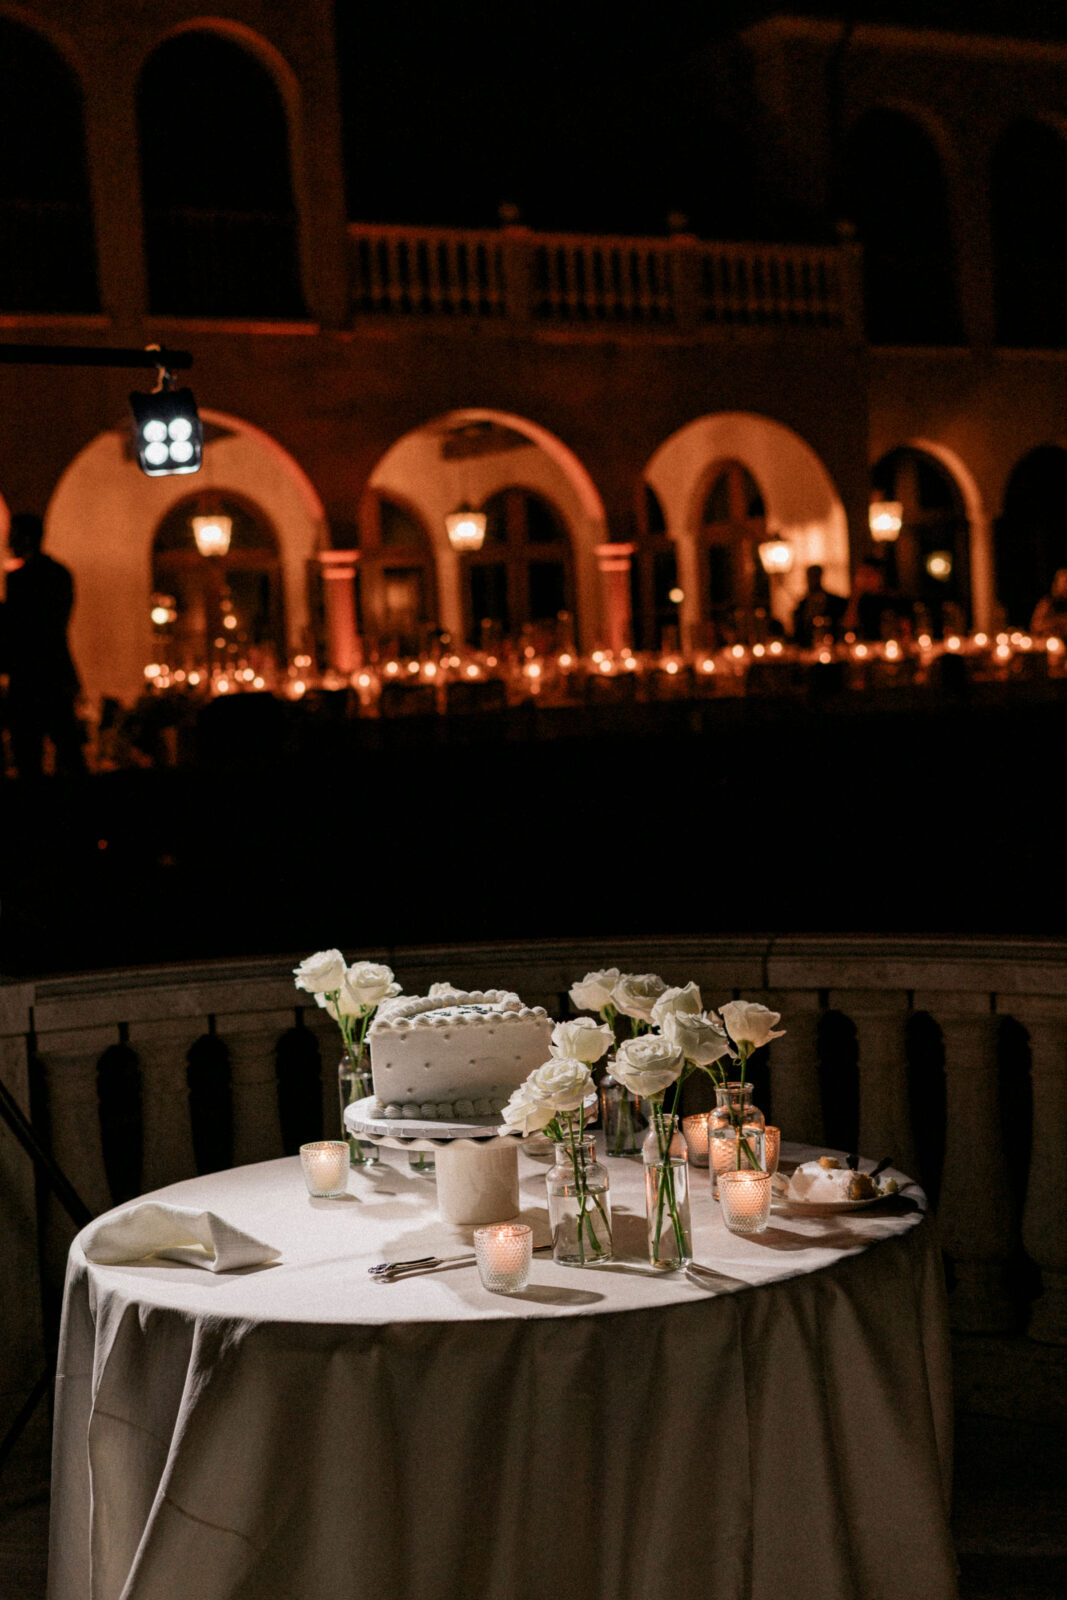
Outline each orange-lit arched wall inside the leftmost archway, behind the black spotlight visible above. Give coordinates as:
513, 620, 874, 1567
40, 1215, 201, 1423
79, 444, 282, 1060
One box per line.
45, 411, 330, 701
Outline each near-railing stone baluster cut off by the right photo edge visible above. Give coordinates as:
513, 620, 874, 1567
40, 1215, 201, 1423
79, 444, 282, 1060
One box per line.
1011, 995, 1067, 1344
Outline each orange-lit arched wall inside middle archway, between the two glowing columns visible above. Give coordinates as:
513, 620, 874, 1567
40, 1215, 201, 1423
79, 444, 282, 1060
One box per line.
368, 406, 608, 650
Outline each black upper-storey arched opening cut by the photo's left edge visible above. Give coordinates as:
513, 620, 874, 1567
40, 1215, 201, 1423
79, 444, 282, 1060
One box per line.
0, 18, 99, 312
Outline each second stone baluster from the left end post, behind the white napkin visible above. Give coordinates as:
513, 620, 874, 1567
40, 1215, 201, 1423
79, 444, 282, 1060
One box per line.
128, 1018, 206, 1190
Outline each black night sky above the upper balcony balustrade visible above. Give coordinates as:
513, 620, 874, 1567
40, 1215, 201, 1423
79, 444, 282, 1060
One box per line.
336, 0, 1067, 237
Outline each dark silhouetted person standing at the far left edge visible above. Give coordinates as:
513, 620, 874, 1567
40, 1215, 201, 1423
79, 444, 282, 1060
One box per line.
0, 512, 85, 778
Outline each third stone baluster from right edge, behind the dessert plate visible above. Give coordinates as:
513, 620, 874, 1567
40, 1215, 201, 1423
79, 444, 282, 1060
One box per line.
830, 989, 915, 1176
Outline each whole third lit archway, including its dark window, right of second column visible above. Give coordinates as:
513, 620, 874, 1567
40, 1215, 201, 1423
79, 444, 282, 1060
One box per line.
640, 411, 849, 646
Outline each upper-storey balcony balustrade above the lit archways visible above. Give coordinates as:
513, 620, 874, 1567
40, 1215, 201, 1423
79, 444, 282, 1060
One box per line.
349, 222, 861, 336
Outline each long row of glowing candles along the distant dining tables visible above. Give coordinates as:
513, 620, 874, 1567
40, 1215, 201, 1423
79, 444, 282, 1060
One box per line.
144, 630, 1067, 707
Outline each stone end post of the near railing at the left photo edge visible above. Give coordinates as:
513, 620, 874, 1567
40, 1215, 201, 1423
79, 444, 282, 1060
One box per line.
0, 1024, 43, 1414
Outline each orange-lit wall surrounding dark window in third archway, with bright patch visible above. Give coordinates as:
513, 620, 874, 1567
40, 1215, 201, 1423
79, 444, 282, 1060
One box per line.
645, 411, 849, 637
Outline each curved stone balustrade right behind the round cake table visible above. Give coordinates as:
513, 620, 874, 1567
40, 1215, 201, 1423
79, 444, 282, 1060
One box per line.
0, 938, 1067, 1420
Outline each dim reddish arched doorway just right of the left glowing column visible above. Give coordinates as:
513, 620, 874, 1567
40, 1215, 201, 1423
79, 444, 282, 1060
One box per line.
357, 494, 437, 656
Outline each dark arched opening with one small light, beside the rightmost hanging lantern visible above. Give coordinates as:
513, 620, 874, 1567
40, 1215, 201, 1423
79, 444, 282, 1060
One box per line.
870, 445, 971, 632
